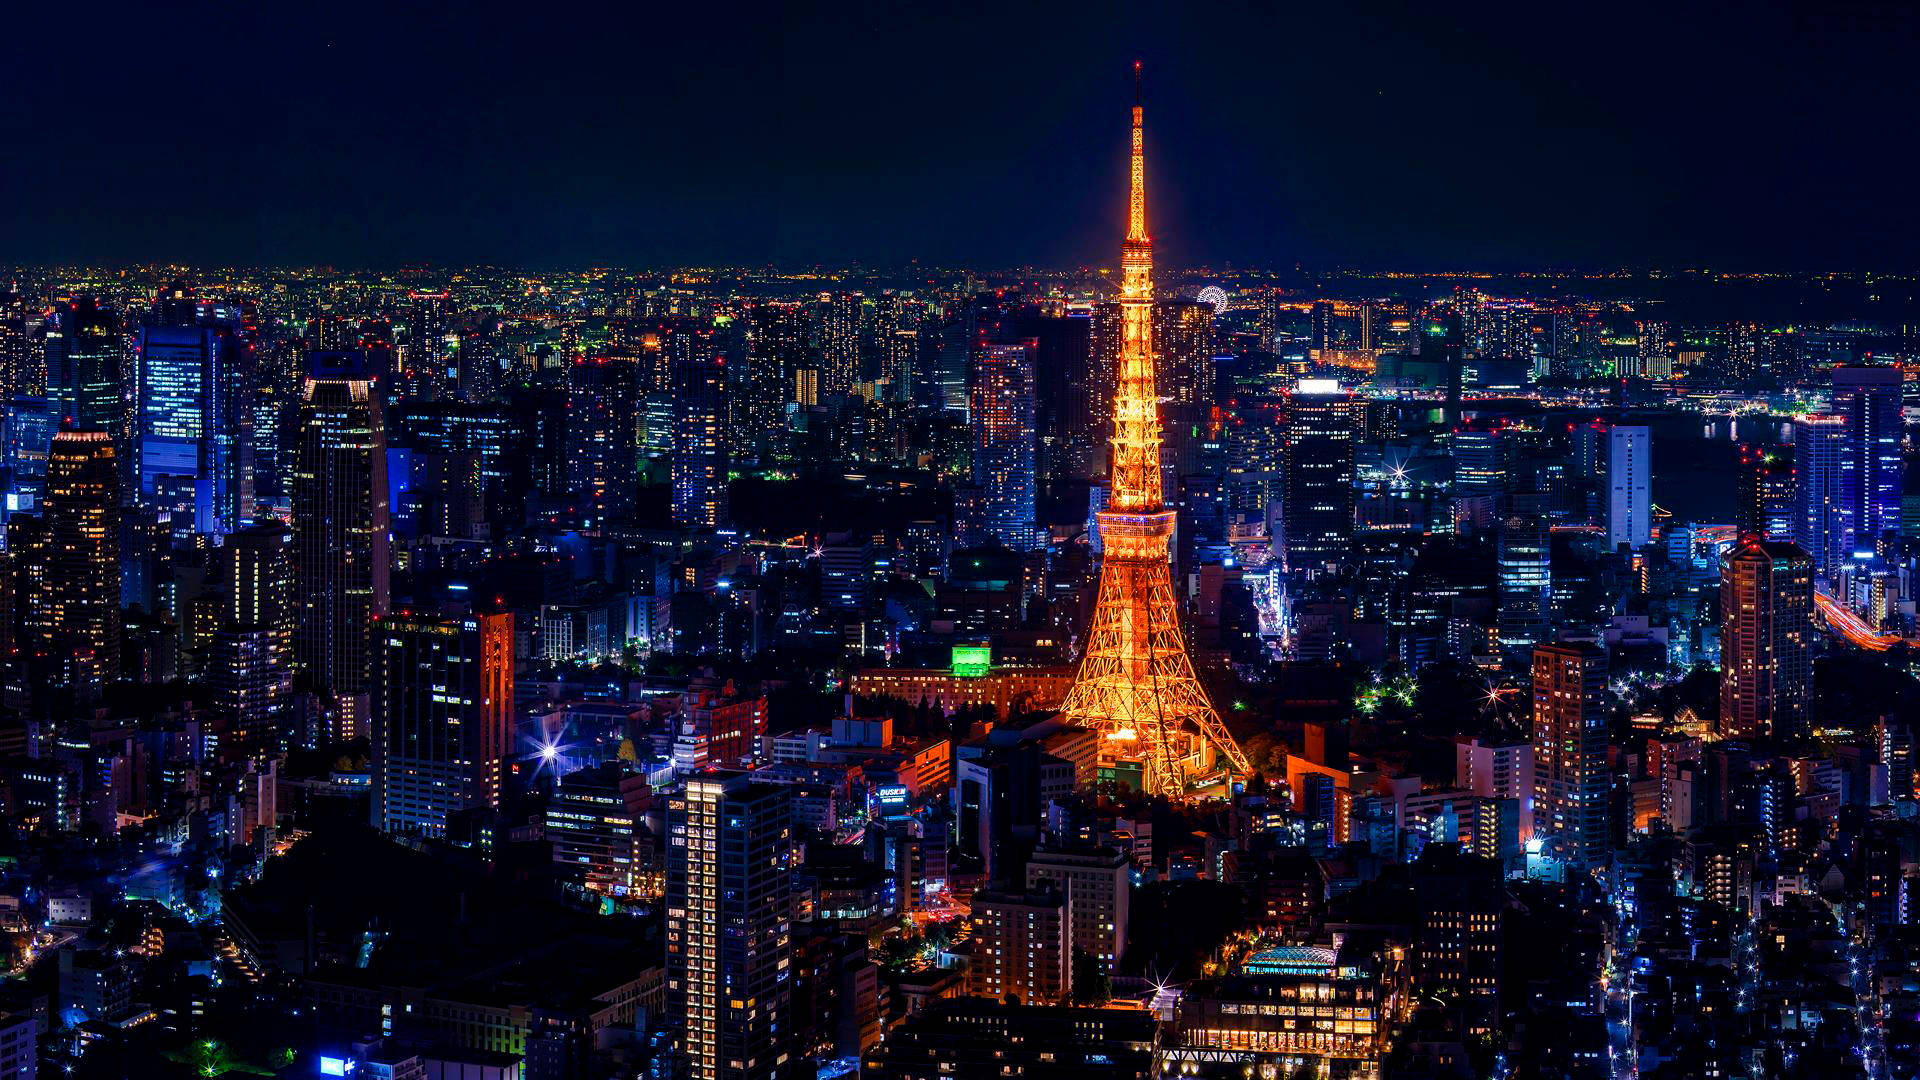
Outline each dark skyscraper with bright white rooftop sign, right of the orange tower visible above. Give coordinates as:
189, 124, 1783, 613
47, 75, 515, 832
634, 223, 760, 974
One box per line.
1281, 379, 1367, 573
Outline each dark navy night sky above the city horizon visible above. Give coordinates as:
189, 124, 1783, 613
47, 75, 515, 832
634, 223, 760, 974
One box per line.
0, 2, 1920, 269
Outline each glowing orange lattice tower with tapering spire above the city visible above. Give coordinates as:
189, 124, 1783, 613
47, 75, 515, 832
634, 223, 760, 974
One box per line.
1062, 63, 1248, 798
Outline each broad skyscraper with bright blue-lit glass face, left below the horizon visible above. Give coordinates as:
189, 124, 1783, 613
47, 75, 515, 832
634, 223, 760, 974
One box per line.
131, 325, 252, 532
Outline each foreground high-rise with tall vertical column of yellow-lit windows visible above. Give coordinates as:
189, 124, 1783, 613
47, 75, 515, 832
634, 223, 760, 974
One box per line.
666, 773, 793, 1080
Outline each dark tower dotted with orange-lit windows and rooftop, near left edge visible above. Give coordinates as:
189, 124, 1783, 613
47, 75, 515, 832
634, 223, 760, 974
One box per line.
35, 429, 121, 696
